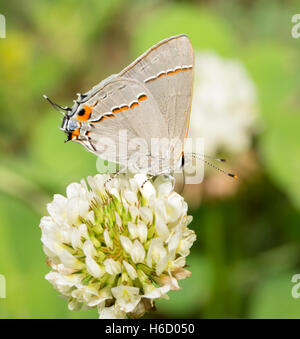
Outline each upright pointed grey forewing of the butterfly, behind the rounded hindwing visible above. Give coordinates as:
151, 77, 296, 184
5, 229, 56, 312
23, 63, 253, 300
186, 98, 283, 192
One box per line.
119, 34, 194, 146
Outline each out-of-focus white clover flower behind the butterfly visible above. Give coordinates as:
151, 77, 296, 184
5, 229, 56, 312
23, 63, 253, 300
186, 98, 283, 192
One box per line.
190, 52, 258, 155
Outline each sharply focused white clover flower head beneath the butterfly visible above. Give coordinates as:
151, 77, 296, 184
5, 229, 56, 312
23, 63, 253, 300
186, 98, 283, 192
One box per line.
40, 174, 196, 319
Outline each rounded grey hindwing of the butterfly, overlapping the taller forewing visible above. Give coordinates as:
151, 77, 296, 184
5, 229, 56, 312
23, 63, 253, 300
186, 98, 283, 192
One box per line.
77, 77, 167, 166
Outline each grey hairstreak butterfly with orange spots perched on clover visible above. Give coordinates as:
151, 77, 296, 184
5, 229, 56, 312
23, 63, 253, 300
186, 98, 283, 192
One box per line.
44, 34, 194, 175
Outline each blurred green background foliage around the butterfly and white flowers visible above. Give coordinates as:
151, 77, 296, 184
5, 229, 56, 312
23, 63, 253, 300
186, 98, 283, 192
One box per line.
0, 0, 300, 318
